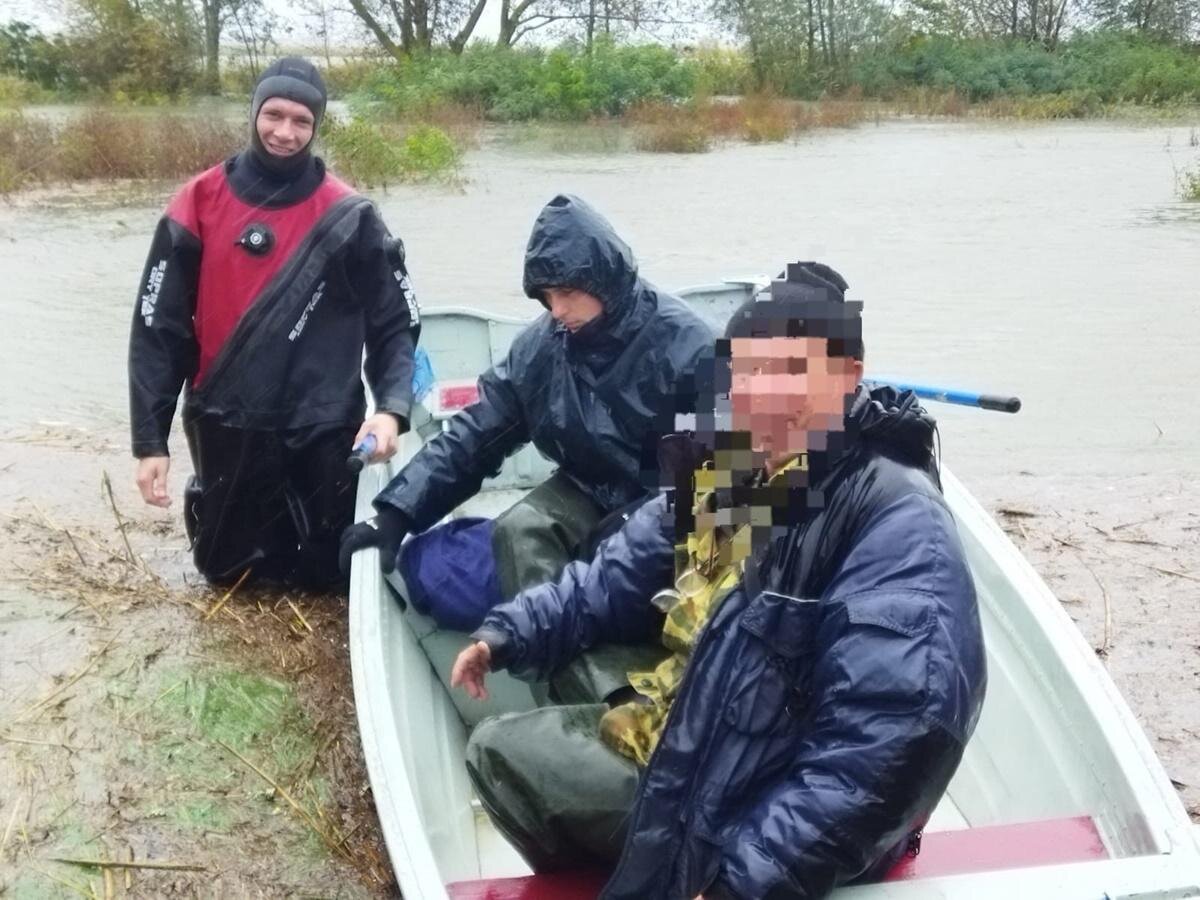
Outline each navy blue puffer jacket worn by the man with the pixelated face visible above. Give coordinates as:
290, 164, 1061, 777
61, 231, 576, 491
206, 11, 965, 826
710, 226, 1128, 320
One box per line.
476, 388, 986, 900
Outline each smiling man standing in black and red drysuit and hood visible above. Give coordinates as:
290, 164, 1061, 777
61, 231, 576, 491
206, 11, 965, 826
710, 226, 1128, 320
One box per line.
130, 58, 419, 588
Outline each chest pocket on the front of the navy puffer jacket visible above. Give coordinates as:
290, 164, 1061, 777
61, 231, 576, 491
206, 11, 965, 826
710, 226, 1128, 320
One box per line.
725, 590, 821, 734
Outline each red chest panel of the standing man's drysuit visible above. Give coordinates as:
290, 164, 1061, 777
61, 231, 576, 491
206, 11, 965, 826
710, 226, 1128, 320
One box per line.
167, 166, 352, 385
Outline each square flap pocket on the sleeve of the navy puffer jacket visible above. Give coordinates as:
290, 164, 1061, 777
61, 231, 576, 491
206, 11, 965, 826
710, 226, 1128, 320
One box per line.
836, 590, 935, 710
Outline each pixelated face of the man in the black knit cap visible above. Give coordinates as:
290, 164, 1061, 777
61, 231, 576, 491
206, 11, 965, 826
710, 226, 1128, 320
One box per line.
730, 337, 863, 460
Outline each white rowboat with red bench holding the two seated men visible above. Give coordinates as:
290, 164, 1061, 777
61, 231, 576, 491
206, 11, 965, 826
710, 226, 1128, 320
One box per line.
352, 292, 1200, 900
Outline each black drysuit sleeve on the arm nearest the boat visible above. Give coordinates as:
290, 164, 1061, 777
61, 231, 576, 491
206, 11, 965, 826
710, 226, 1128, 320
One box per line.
347, 206, 421, 431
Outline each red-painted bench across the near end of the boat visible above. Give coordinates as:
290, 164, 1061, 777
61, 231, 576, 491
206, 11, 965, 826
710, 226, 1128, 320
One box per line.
448, 816, 1109, 900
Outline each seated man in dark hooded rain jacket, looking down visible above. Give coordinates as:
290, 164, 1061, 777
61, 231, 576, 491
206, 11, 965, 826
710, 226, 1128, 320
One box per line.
343, 196, 713, 657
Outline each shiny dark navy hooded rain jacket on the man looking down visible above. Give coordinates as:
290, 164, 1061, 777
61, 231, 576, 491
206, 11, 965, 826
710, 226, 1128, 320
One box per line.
376, 190, 713, 530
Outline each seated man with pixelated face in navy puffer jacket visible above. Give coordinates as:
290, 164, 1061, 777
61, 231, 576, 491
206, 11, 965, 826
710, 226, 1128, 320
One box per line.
454, 264, 986, 900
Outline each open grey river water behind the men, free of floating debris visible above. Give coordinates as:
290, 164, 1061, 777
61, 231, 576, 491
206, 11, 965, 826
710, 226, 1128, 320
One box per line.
0, 121, 1200, 487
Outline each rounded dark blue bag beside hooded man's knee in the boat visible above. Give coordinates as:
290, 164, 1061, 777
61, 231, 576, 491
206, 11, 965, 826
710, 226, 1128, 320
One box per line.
398, 518, 502, 631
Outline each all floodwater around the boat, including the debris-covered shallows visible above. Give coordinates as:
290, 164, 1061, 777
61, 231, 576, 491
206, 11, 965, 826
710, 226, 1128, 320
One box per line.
0, 121, 1200, 896
